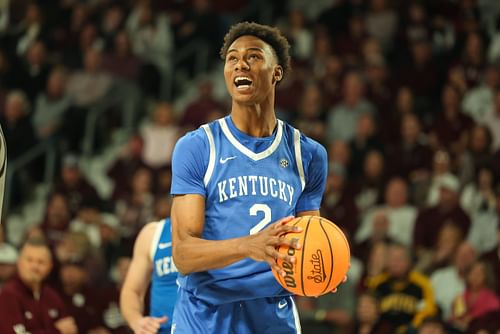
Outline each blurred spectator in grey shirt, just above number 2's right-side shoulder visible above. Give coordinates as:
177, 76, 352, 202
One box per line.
326, 72, 375, 143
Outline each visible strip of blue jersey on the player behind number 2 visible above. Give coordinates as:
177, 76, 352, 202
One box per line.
150, 218, 178, 333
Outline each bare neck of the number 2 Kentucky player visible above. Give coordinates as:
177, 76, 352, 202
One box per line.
231, 102, 276, 137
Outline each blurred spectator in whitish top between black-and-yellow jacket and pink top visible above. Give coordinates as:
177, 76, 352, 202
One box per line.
431, 242, 477, 320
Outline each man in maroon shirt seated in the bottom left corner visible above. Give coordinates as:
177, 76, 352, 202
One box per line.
0, 239, 77, 334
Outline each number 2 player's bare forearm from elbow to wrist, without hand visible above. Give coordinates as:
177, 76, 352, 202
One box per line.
173, 237, 248, 275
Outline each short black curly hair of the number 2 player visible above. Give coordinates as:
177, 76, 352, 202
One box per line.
220, 22, 291, 77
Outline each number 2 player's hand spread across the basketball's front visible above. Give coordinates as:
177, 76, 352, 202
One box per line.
244, 216, 302, 276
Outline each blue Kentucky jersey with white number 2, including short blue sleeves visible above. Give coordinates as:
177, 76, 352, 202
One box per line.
171, 116, 327, 305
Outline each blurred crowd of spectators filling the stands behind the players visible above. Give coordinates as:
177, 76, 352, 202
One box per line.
0, 0, 500, 334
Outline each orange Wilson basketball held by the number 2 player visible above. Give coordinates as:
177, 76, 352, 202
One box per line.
273, 216, 351, 297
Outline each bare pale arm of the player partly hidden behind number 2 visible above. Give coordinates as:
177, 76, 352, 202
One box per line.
120, 223, 167, 334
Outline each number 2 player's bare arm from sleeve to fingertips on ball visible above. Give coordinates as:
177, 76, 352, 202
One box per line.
171, 194, 301, 275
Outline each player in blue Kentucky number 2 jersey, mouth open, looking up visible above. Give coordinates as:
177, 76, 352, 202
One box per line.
171, 22, 327, 334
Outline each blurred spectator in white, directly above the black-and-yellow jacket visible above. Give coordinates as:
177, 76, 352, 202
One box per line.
356, 178, 417, 247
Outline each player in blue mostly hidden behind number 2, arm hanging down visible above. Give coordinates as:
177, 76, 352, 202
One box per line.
120, 218, 177, 334
